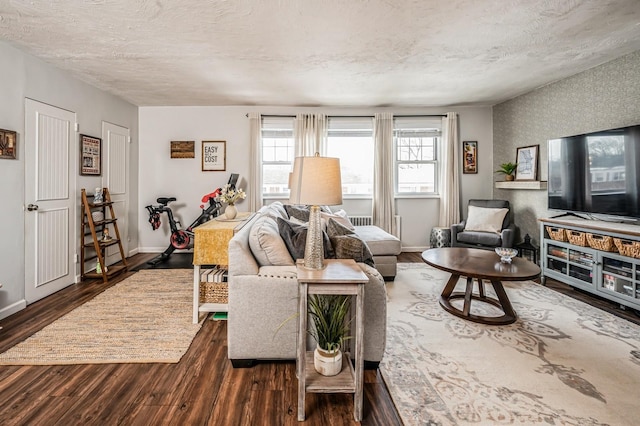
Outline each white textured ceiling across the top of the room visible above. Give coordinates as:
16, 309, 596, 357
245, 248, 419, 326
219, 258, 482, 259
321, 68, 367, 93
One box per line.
0, 0, 640, 107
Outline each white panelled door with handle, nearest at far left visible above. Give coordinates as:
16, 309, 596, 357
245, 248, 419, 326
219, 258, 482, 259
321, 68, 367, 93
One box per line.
25, 99, 78, 303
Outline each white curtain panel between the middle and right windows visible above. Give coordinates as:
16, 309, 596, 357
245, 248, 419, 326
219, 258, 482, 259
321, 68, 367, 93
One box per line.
372, 112, 398, 235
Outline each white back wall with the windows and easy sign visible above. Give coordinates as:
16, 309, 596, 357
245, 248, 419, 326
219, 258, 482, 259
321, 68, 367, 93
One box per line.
139, 107, 493, 252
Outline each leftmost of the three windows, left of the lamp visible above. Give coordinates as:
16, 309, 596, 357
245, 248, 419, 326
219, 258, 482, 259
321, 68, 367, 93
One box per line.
262, 117, 294, 197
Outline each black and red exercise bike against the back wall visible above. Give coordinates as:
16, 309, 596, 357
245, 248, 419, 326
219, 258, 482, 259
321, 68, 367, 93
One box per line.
145, 188, 222, 266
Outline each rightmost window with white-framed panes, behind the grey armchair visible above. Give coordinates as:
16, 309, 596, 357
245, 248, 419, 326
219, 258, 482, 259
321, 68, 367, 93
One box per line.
393, 117, 442, 195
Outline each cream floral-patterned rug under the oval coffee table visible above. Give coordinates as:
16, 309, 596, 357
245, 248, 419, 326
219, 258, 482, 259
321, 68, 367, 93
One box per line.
380, 264, 640, 426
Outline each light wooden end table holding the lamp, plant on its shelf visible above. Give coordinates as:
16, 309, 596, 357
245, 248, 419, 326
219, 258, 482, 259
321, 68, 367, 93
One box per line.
296, 259, 369, 422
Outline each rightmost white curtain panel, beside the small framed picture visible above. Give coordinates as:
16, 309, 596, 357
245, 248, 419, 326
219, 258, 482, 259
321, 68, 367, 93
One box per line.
438, 112, 460, 227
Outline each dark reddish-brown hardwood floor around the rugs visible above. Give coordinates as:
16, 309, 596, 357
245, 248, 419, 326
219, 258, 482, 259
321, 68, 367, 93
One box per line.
0, 253, 640, 426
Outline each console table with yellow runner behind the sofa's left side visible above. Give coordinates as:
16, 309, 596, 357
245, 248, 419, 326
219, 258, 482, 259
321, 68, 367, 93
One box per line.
193, 212, 254, 324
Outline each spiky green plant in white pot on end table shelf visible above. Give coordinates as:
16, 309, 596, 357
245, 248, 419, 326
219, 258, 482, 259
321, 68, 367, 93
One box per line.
308, 294, 351, 376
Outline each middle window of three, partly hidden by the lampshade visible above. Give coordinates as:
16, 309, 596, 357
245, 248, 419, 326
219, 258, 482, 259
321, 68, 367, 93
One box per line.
326, 117, 375, 198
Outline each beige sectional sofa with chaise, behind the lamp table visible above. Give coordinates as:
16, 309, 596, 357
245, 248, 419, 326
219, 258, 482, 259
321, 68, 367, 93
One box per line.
227, 202, 400, 368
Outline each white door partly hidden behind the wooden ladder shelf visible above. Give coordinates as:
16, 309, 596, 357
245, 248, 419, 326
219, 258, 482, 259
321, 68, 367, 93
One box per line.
102, 121, 130, 265
